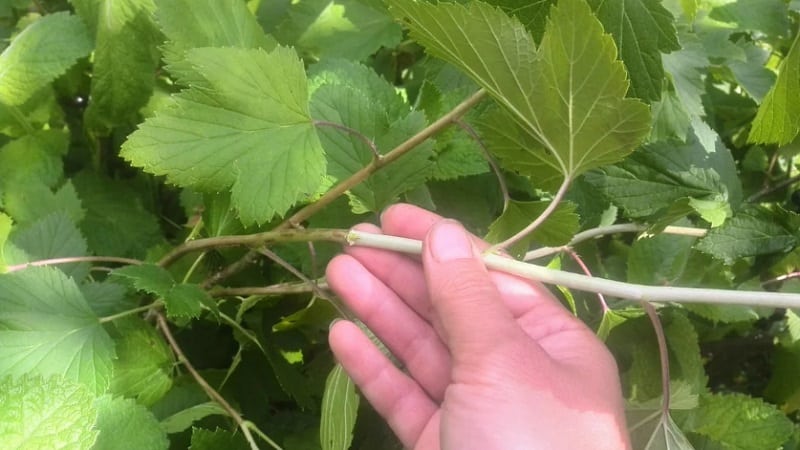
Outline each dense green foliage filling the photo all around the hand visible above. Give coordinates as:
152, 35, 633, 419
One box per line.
0, 0, 800, 450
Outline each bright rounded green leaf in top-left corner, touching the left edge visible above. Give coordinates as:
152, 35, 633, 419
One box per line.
0, 12, 92, 106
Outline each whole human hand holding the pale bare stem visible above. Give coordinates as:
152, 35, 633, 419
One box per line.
327, 204, 630, 450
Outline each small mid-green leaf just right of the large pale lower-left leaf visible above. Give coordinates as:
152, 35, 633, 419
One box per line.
111, 320, 174, 406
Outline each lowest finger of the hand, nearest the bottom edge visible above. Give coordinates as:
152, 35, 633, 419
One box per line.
328, 321, 438, 448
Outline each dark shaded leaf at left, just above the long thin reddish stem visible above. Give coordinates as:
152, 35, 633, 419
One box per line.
72, 172, 162, 258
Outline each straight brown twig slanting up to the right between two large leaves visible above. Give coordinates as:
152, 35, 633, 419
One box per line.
203, 89, 486, 287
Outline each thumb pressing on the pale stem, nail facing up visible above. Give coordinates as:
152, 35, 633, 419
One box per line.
422, 220, 521, 361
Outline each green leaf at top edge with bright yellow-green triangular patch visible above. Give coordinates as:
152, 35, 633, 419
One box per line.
276, 0, 403, 61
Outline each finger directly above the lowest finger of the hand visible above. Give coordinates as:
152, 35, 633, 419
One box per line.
326, 255, 450, 401
